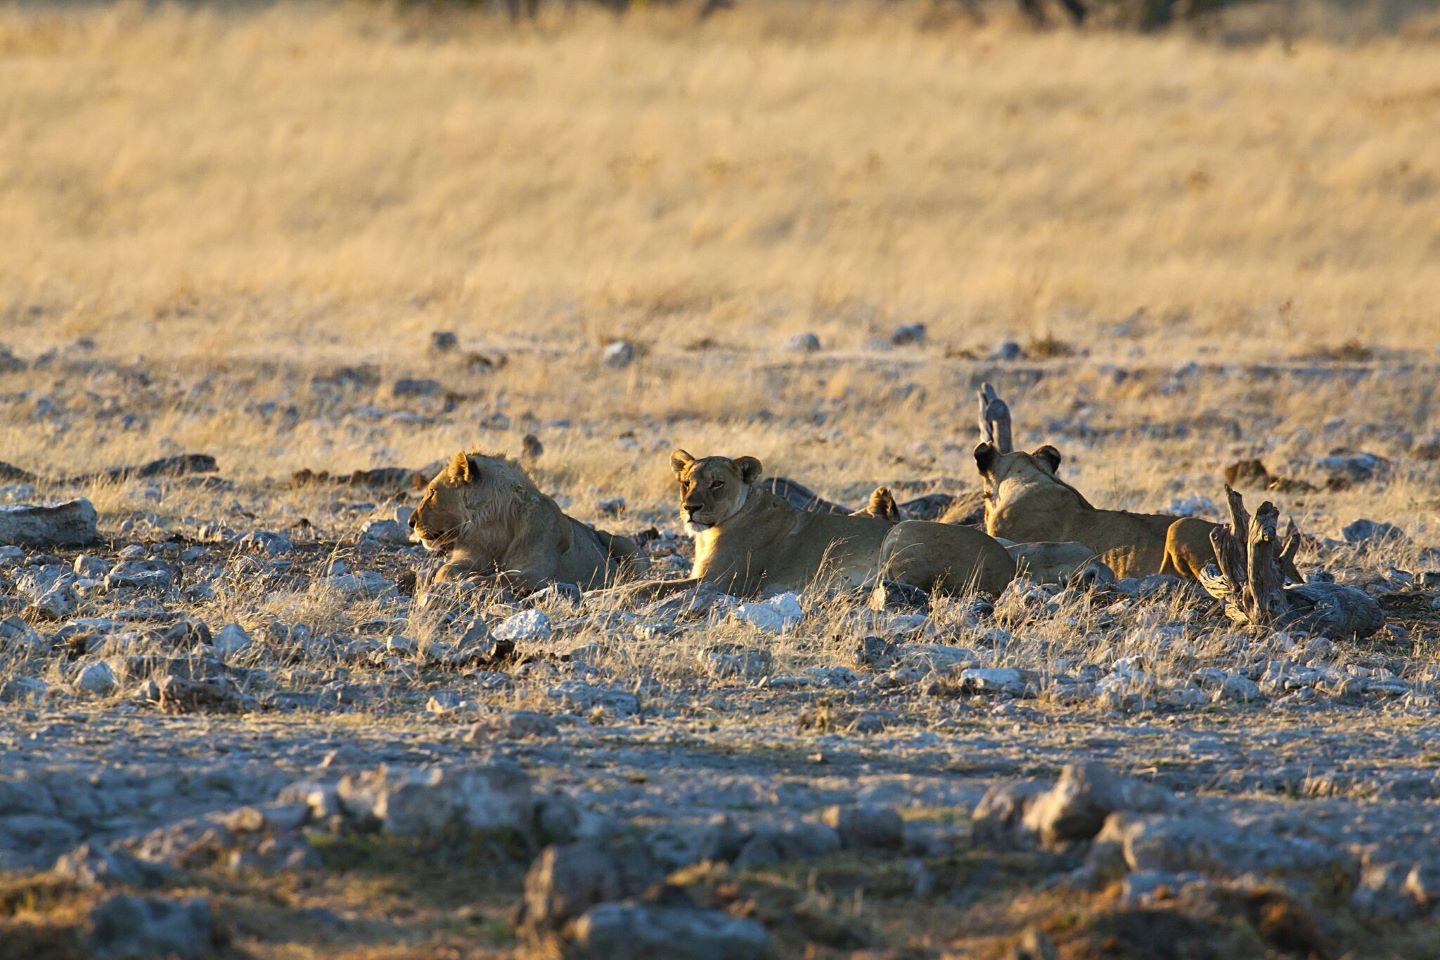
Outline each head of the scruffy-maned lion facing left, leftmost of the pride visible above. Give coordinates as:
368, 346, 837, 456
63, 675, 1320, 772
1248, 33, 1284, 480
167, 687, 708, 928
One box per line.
410, 452, 534, 553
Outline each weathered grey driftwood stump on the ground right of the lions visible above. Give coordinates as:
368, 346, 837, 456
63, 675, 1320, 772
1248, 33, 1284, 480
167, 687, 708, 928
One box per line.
1200, 486, 1385, 638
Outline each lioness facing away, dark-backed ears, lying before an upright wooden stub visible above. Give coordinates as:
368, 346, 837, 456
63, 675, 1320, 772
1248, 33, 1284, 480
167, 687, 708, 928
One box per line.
975, 442, 1175, 577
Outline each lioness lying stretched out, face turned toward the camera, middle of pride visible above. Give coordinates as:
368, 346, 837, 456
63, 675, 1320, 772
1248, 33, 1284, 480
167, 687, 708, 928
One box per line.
625, 449, 1014, 599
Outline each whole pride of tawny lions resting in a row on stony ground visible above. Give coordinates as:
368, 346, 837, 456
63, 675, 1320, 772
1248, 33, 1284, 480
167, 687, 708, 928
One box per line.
410, 384, 1303, 600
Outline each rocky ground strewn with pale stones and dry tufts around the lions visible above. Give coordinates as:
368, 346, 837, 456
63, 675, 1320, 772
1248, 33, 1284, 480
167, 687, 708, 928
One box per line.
0, 339, 1440, 959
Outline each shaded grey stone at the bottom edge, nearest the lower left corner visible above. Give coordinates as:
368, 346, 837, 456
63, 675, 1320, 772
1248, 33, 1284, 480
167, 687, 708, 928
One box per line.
88, 894, 215, 960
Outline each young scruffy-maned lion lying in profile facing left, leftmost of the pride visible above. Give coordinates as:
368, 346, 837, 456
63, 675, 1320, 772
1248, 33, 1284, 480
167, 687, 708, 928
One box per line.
410, 452, 641, 590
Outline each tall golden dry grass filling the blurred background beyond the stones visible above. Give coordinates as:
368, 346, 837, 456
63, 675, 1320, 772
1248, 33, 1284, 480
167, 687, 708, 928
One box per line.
0, 3, 1440, 361
